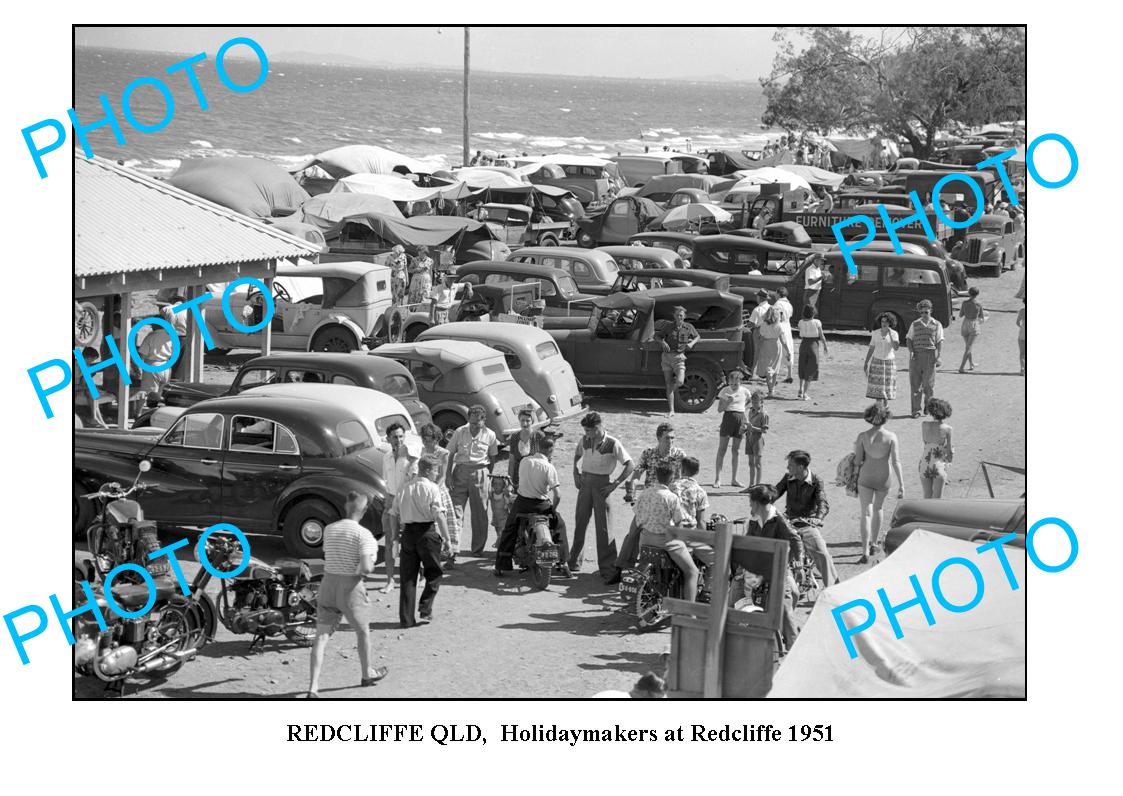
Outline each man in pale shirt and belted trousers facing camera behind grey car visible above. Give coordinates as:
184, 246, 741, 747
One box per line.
446, 404, 499, 556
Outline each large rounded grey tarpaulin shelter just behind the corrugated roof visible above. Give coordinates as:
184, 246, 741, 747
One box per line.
167, 157, 308, 218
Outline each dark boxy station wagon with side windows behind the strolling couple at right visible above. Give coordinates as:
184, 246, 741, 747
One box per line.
732, 251, 952, 333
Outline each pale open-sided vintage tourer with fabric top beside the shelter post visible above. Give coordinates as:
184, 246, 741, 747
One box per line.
207, 263, 390, 351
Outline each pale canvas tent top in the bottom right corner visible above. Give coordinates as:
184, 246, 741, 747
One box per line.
768, 531, 1025, 698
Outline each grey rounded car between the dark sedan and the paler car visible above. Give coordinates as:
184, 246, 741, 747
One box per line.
369, 340, 549, 436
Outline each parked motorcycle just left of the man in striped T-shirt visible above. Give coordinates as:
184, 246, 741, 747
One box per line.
181, 533, 320, 652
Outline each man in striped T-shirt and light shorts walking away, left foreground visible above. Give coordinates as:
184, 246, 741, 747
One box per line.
308, 492, 389, 699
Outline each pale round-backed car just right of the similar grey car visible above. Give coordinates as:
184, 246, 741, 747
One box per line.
418, 322, 585, 422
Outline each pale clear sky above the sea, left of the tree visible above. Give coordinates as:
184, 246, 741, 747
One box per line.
75, 27, 790, 82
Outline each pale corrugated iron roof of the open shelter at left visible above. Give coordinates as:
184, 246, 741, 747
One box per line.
74, 153, 319, 276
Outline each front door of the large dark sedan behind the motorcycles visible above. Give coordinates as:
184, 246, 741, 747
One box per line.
144, 412, 226, 527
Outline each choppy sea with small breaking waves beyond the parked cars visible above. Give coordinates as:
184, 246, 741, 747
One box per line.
74, 48, 765, 175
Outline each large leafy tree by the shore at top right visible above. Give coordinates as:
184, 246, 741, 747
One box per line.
760, 27, 1025, 157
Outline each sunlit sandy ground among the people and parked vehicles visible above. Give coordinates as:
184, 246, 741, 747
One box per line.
75, 269, 1025, 698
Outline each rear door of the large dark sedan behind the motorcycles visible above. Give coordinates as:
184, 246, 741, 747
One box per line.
221, 414, 302, 531
